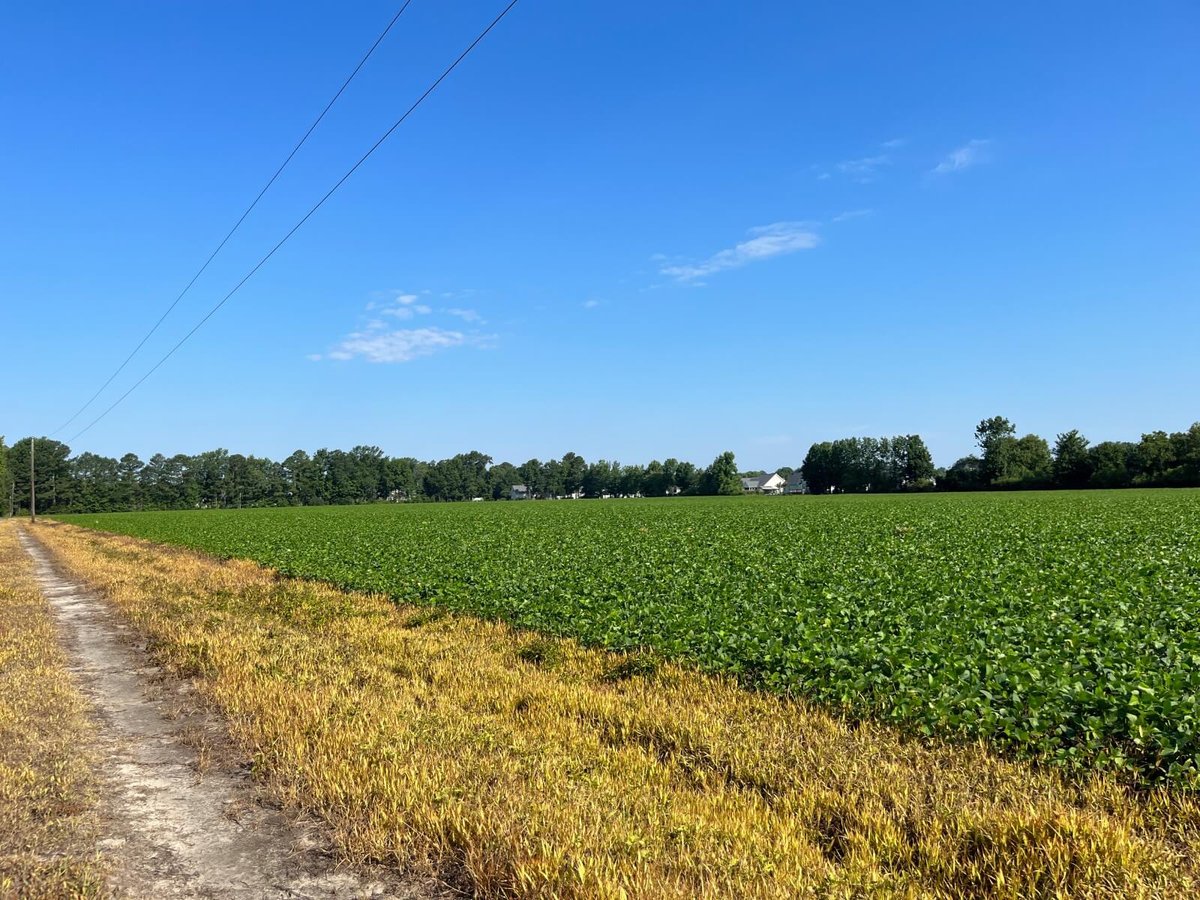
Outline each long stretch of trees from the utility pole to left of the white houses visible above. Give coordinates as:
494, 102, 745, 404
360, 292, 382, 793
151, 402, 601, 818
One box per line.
0, 438, 742, 512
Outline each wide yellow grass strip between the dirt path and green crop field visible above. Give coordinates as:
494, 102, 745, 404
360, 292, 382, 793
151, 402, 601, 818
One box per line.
25, 524, 1200, 899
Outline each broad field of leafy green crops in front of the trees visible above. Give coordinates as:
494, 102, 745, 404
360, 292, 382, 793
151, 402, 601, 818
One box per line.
60, 491, 1200, 787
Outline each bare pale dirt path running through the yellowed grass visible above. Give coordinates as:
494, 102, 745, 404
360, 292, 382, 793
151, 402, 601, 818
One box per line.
19, 530, 439, 900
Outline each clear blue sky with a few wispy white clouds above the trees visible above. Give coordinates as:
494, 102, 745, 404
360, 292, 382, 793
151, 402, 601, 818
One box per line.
0, 0, 1200, 468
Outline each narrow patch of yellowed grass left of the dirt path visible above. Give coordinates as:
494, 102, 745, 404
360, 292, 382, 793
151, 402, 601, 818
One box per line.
0, 522, 103, 898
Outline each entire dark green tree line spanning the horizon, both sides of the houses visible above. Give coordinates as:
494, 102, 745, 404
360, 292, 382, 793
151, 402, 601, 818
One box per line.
0, 416, 1200, 512
